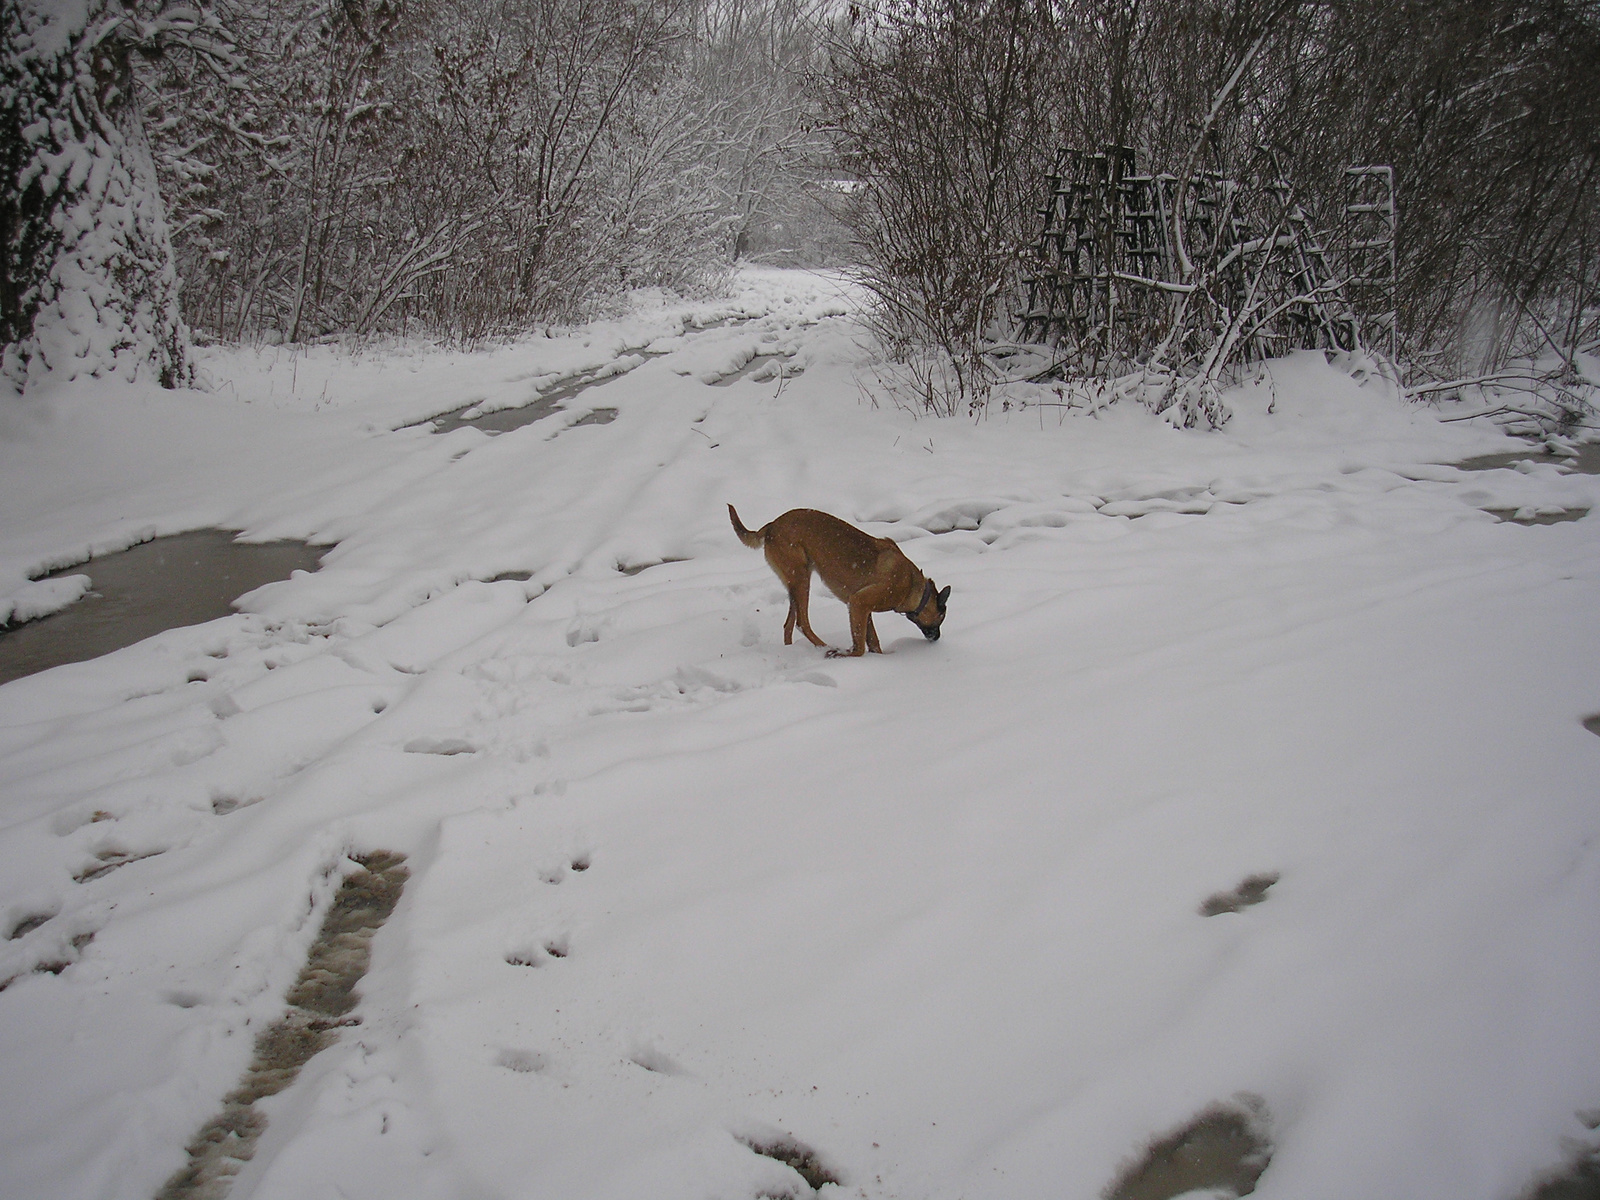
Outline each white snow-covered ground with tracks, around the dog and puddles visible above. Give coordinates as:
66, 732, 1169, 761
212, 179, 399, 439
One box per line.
0, 272, 1600, 1200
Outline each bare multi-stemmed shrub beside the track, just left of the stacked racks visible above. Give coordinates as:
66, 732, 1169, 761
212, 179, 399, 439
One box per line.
830, 0, 1059, 411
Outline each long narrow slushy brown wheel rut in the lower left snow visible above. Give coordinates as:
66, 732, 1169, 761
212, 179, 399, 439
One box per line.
157, 851, 411, 1200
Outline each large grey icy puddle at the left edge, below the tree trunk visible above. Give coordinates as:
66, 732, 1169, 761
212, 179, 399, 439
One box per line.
0, 530, 330, 683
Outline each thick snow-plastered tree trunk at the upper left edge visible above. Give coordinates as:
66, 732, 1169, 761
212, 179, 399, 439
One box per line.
0, 0, 194, 392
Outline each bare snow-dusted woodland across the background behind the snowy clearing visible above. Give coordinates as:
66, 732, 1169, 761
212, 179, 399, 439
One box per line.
0, 0, 1600, 404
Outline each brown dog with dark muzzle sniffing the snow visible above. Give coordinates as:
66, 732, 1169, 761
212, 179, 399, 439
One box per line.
728, 504, 950, 658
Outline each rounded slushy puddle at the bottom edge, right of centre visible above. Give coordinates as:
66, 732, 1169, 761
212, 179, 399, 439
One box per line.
1104, 1096, 1272, 1200
